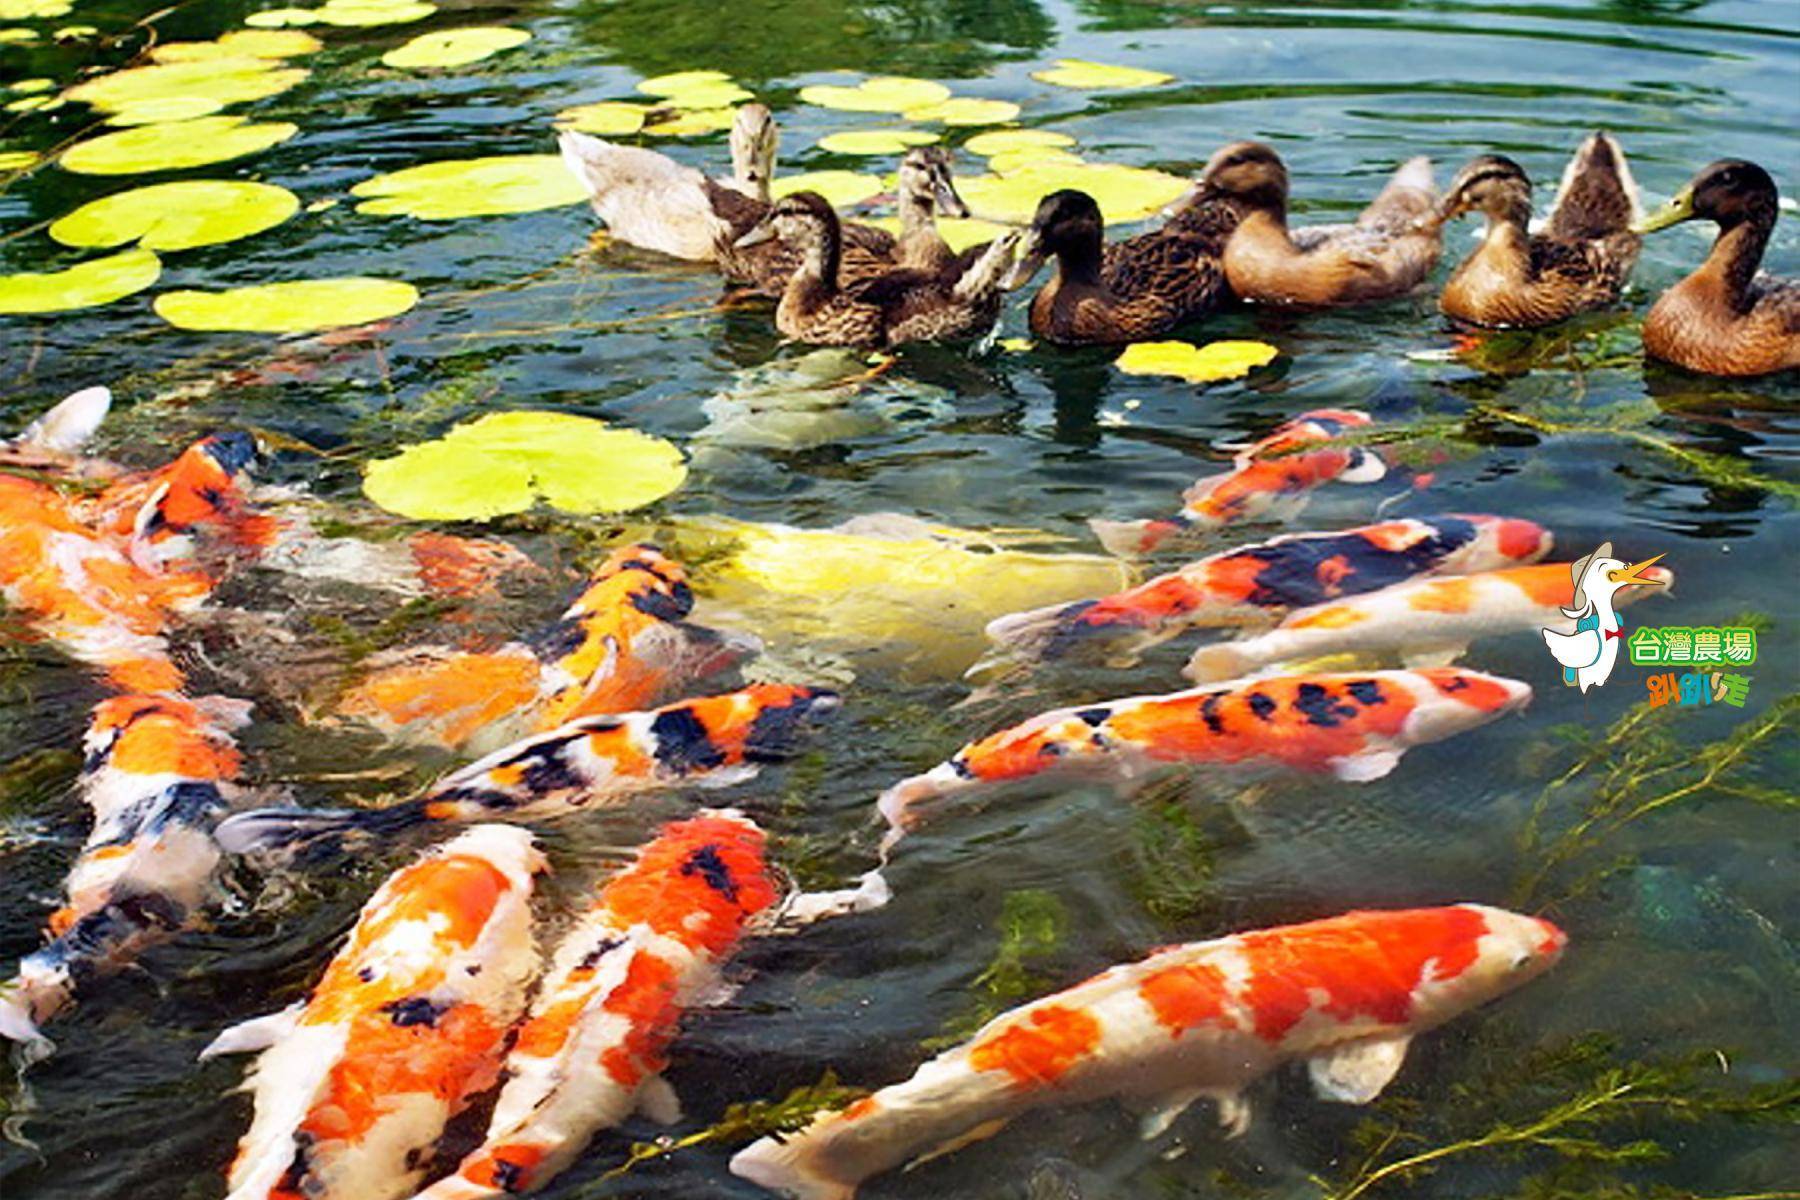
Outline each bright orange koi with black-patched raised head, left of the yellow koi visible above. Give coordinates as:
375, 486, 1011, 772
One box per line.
337, 545, 760, 748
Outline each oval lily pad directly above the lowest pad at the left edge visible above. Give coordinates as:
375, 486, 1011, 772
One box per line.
50, 180, 301, 250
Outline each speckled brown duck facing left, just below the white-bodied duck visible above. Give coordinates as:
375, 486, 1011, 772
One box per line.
738, 191, 1019, 347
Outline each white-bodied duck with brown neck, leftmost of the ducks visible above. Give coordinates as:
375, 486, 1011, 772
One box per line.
556, 104, 779, 263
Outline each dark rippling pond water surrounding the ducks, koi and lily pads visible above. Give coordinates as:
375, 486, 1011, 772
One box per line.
0, 0, 1800, 1200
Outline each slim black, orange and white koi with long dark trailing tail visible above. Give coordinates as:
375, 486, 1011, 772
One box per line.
218, 684, 839, 855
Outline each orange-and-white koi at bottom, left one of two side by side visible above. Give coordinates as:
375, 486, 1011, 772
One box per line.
200, 826, 544, 1200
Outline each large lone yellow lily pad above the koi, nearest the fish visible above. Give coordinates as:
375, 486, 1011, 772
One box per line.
362, 412, 688, 520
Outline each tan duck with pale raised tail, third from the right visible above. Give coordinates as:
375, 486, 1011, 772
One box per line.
1201, 142, 1442, 308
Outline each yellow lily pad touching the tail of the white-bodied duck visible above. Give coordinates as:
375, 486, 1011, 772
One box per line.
349, 155, 587, 221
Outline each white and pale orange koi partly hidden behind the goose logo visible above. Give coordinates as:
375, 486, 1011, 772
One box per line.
1183, 563, 1674, 682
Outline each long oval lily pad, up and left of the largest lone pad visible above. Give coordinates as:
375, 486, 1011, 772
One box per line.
155, 275, 419, 333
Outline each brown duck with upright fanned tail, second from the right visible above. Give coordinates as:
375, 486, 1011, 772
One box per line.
1431, 131, 1640, 329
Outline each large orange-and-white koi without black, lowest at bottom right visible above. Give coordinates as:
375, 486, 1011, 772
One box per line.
731, 903, 1568, 1200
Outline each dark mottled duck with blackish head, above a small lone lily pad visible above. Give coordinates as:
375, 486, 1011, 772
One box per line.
1006, 189, 1237, 345
